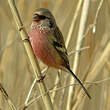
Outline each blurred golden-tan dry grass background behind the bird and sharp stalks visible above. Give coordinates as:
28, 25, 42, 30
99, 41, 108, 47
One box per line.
0, 0, 110, 110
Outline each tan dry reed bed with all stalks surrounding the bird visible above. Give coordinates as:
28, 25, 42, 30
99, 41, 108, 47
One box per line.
0, 0, 110, 110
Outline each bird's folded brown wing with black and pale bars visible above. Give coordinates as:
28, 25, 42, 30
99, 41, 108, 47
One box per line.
52, 27, 69, 67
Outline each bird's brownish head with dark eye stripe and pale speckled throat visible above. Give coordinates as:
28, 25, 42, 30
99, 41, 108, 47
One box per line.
32, 8, 56, 29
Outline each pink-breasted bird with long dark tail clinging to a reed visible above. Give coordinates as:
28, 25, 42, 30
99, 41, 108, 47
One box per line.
29, 8, 91, 99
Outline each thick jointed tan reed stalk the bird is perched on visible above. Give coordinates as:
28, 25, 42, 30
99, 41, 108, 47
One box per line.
8, 0, 53, 110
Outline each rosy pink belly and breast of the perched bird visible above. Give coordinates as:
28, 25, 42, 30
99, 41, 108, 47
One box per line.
31, 30, 61, 68
